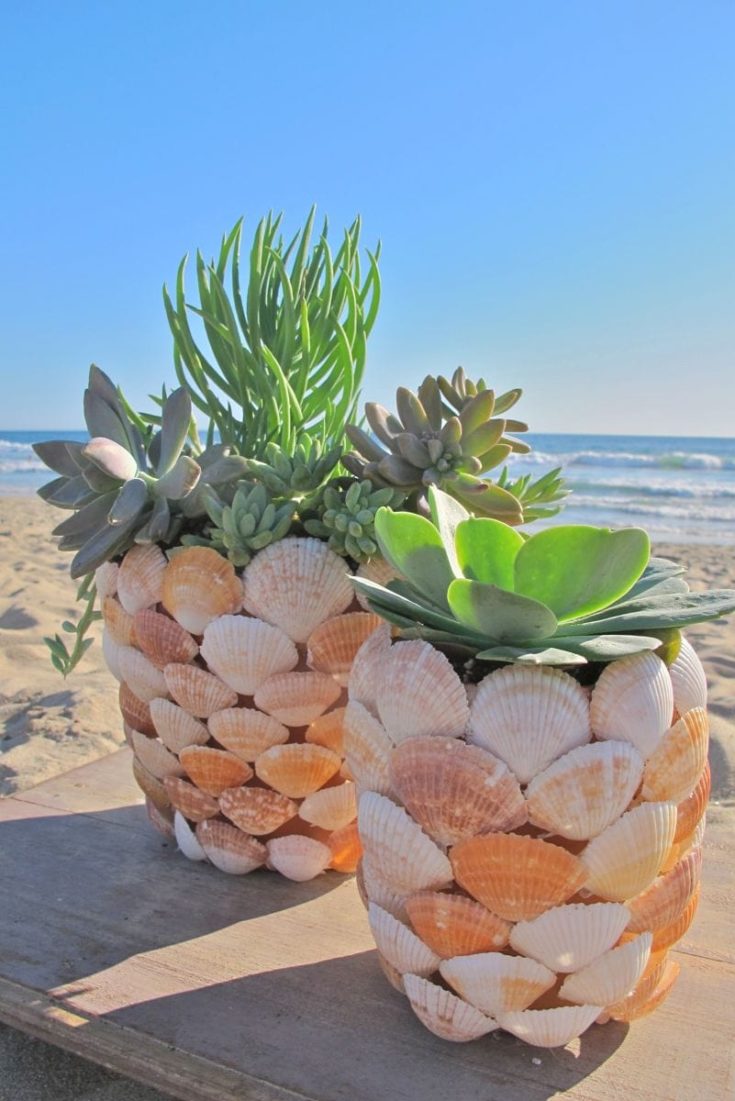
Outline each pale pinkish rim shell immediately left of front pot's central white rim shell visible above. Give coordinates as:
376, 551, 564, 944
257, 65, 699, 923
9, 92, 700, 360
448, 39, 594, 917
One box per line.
377, 639, 470, 743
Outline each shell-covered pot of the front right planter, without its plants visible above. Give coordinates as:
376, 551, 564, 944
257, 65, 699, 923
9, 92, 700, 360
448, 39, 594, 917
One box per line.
344, 626, 710, 1047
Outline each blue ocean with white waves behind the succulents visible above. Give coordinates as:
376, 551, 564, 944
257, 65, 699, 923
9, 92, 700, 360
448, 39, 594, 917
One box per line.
0, 429, 735, 545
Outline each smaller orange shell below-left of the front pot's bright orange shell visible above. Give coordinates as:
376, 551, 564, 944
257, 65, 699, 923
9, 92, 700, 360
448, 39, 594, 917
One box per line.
405, 891, 511, 959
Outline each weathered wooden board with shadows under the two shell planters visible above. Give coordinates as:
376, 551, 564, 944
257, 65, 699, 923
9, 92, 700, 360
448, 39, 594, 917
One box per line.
0, 738, 735, 1101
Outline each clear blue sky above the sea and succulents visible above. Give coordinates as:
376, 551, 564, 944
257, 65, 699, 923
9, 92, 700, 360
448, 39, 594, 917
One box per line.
0, 0, 735, 436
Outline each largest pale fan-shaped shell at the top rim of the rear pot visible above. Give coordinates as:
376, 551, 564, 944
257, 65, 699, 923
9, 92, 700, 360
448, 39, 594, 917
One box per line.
242, 537, 353, 642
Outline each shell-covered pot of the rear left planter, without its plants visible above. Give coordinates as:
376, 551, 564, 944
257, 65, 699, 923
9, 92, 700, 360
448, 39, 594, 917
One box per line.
97, 537, 380, 881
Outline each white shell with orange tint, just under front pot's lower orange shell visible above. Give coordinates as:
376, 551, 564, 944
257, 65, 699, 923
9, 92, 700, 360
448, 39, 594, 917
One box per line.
439, 952, 557, 1017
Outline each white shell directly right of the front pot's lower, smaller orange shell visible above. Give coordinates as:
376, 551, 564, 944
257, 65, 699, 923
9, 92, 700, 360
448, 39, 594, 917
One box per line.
511, 902, 630, 974
